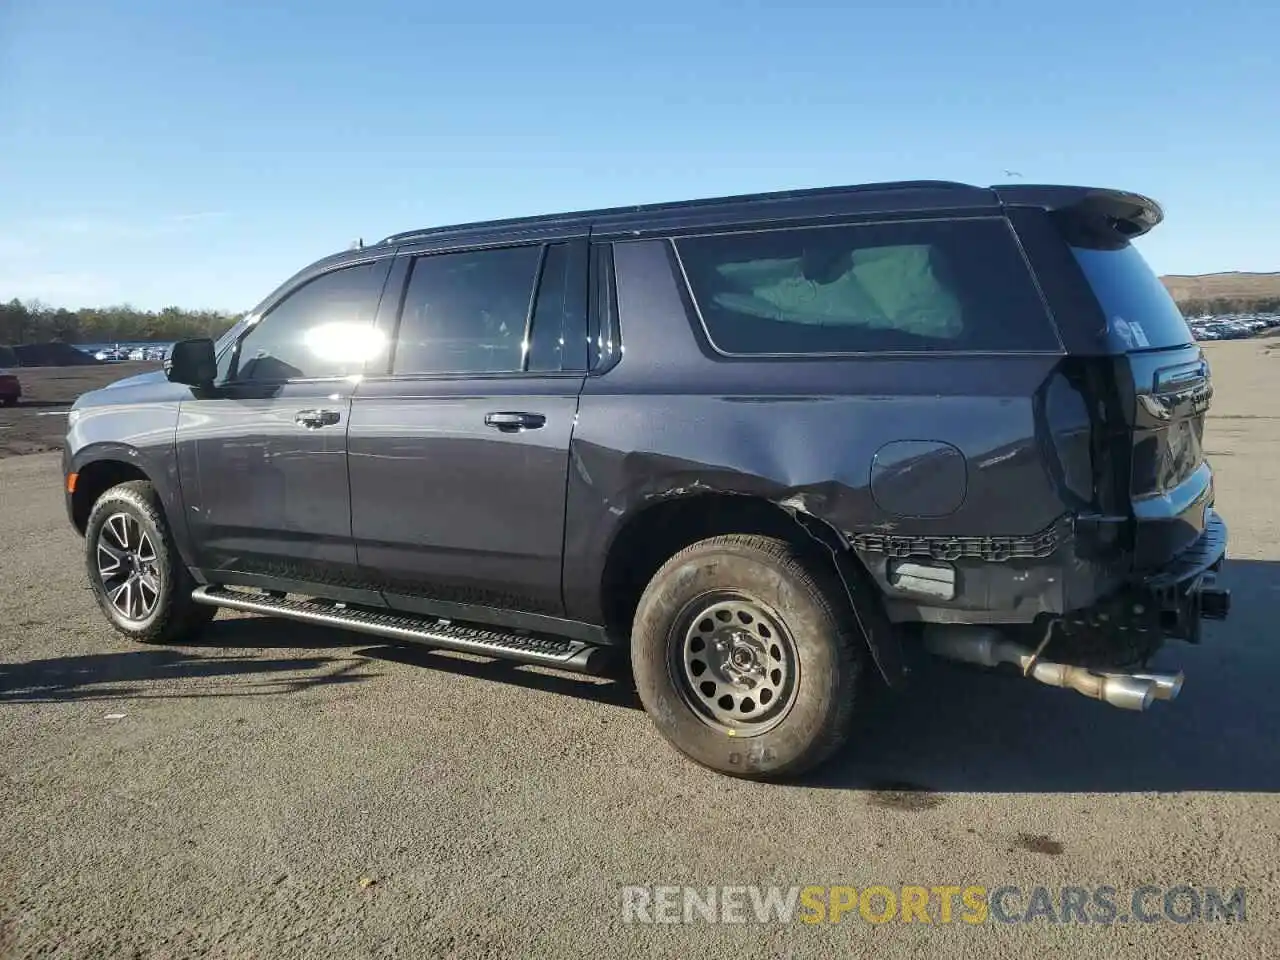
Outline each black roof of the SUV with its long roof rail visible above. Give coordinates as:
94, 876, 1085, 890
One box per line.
381, 180, 1161, 244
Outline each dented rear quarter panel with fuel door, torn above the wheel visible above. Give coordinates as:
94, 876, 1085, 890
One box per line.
563, 241, 1064, 640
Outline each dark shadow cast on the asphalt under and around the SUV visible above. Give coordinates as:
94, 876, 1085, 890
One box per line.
0, 561, 1280, 793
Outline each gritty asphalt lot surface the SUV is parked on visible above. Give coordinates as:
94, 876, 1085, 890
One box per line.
0, 342, 1280, 960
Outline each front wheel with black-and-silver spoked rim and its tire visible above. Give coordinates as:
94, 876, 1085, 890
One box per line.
84, 480, 218, 644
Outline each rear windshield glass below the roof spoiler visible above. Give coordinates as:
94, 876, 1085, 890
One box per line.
1071, 244, 1192, 352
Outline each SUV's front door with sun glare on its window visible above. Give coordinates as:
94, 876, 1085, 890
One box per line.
178, 259, 389, 585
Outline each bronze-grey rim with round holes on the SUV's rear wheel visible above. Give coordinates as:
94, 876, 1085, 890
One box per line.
671, 596, 800, 736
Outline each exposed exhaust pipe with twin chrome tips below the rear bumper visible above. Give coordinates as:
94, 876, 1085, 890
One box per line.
924, 625, 1183, 710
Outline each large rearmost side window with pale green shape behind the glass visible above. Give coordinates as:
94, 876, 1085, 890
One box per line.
675, 218, 1060, 355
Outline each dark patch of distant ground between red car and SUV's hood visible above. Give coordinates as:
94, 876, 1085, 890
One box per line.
0, 362, 160, 458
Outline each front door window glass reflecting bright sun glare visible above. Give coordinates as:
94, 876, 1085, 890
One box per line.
230, 260, 388, 383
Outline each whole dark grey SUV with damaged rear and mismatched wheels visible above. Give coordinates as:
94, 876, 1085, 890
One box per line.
64, 182, 1229, 778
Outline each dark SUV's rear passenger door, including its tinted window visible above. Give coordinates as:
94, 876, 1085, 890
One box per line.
348, 239, 588, 616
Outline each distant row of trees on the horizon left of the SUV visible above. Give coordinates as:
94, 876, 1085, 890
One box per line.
0, 298, 242, 344
